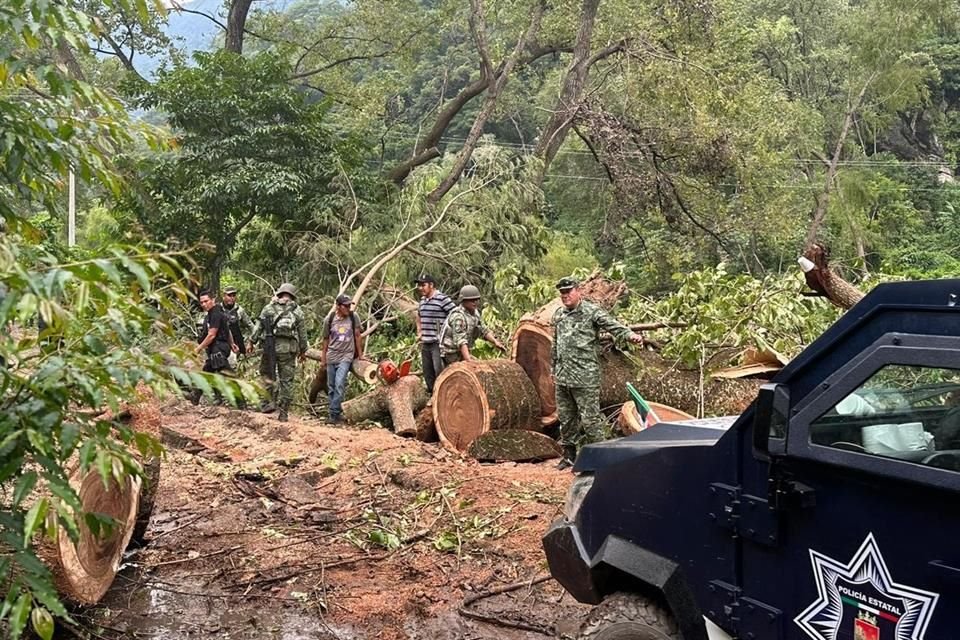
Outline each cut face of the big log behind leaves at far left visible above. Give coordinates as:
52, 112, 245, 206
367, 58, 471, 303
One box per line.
38, 464, 141, 604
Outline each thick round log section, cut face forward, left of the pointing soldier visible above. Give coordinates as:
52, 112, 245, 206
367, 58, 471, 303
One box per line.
433, 359, 542, 453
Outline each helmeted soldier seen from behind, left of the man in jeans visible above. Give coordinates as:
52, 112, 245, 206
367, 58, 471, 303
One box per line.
250, 282, 308, 422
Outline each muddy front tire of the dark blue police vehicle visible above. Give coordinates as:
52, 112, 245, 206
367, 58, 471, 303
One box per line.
577, 593, 683, 640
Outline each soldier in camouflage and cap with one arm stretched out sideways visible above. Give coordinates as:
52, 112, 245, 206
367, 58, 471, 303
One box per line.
551, 278, 643, 468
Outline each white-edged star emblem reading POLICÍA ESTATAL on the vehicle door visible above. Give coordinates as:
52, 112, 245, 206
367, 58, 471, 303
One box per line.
794, 533, 940, 640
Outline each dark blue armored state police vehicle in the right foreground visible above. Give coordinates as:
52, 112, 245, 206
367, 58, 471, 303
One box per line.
543, 280, 960, 640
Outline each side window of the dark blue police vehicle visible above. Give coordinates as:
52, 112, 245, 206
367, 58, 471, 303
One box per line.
810, 365, 960, 471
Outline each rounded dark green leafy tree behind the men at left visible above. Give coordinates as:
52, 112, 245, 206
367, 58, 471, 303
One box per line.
124, 51, 357, 286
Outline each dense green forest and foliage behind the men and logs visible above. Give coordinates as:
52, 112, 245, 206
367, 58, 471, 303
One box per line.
0, 0, 960, 637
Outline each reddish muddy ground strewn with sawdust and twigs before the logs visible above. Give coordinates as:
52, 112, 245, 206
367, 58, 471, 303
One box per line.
71, 402, 586, 640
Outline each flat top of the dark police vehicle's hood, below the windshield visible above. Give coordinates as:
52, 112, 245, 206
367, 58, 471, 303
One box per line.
573, 416, 740, 472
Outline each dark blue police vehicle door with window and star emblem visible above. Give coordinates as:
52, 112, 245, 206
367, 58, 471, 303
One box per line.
741, 334, 960, 640
